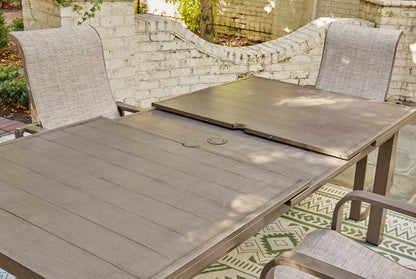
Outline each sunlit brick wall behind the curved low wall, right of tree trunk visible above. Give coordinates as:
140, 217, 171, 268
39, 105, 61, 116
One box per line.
214, 0, 360, 41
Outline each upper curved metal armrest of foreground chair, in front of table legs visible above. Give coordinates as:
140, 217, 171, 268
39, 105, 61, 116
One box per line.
332, 190, 416, 232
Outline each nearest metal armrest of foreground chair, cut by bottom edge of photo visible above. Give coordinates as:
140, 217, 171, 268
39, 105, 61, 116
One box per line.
260, 251, 364, 279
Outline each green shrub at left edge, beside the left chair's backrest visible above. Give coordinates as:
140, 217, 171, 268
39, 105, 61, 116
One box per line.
0, 64, 28, 107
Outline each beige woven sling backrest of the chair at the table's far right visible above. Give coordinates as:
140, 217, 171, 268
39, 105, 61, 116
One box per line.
316, 22, 402, 101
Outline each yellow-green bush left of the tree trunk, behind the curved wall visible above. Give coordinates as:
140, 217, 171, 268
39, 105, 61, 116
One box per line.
165, 0, 201, 32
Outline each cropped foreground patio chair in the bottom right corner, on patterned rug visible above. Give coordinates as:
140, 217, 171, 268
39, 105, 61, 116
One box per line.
260, 191, 416, 279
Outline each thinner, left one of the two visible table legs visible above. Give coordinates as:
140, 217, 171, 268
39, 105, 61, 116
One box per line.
350, 156, 368, 221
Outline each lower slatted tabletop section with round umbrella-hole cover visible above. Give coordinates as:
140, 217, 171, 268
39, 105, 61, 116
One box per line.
0, 77, 414, 278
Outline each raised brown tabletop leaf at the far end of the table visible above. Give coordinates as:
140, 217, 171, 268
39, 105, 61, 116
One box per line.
153, 77, 415, 159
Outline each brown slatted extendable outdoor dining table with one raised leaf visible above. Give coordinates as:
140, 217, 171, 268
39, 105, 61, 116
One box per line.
0, 78, 416, 278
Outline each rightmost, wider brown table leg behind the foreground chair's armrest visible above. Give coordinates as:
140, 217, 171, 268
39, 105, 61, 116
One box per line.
367, 133, 398, 245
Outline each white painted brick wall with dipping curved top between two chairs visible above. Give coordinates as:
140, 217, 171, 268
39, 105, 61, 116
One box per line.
134, 15, 371, 107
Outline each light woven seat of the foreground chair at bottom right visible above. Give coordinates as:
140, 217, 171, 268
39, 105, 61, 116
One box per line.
267, 229, 416, 278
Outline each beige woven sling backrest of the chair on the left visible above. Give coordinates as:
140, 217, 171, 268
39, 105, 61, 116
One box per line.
9, 25, 119, 129
